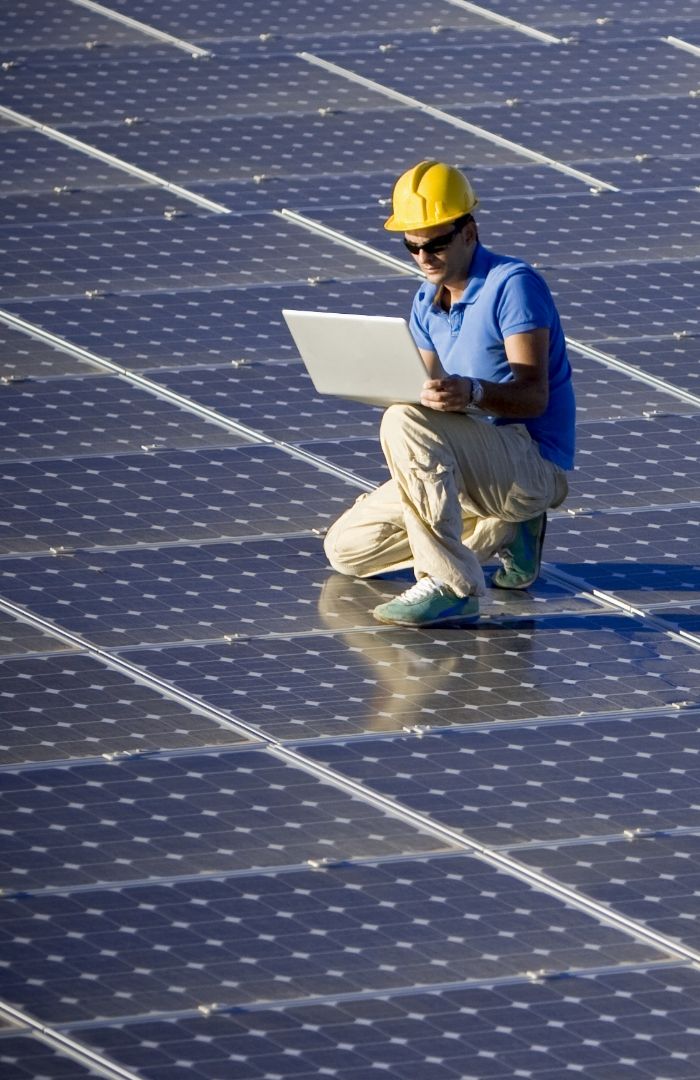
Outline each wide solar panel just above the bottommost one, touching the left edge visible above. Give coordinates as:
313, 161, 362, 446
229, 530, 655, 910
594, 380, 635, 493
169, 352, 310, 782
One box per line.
4, 854, 668, 1024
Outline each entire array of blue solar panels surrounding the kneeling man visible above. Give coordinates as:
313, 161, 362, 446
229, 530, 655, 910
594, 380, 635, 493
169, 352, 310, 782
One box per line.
0, 0, 700, 1080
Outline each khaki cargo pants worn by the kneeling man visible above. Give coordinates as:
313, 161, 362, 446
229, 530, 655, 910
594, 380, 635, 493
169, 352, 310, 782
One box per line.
325, 405, 568, 596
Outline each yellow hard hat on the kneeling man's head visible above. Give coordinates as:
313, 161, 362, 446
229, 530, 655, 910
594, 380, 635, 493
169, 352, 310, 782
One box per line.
385, 161, 479, 232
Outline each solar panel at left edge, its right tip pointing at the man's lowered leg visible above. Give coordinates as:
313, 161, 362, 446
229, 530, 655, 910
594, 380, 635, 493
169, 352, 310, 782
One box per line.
0, 446, 356, 553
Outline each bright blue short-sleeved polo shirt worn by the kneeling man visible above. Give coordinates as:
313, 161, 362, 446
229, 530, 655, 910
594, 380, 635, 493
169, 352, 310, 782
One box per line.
410, 244, 576, 469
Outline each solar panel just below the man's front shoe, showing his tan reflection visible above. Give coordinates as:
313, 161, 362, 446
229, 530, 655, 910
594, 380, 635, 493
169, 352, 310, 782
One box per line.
120, 617, 700, 739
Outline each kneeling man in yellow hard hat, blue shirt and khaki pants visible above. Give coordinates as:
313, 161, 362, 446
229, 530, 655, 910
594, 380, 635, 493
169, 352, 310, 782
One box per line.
325, 161, 575, 626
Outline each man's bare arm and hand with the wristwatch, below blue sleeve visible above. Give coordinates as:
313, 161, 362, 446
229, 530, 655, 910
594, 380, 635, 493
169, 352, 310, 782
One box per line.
420, 327, 549, 420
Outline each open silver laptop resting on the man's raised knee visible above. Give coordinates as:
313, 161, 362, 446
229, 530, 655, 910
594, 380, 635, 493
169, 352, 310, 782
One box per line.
282, 309, 428, 405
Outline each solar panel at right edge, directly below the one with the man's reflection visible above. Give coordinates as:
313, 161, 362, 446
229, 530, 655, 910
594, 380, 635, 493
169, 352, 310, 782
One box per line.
308, 713, 700, 846
